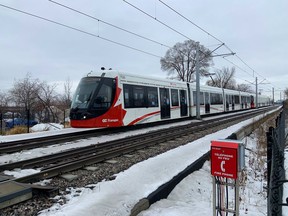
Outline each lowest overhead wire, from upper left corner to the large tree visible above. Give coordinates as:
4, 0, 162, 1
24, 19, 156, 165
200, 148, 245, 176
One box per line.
0, 4, 161, 58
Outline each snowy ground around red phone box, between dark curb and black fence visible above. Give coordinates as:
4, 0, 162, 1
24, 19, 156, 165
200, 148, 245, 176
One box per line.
138, 133, 267, 216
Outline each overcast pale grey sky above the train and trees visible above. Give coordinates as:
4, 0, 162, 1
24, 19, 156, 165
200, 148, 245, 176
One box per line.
0, 0, 288, 99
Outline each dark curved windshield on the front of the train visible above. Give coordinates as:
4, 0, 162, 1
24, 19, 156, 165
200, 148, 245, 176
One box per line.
70, 77, 116, 119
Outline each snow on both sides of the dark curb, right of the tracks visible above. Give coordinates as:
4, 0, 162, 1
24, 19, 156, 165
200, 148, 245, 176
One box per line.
37, 112, 276, 216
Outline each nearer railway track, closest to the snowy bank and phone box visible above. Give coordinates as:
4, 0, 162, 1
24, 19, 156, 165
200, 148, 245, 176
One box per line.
0, 106, 276, 183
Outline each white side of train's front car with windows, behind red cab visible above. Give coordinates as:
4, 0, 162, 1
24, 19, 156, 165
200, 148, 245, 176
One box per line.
119, 74, 189, 125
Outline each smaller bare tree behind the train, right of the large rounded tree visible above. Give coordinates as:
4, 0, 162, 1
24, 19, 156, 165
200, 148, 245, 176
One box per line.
206, 67, 236, 89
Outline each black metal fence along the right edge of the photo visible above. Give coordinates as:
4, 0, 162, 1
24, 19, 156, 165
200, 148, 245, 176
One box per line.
267, 110, 288, 216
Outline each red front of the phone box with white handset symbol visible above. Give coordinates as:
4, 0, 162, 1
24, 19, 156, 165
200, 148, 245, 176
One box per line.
210, 141, 238, 179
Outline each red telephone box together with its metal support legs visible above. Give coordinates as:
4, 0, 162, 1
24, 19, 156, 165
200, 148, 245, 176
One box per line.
210, 140, 245, 216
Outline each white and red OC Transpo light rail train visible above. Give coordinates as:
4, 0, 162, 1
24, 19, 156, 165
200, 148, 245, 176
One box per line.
70, 70, 270, 128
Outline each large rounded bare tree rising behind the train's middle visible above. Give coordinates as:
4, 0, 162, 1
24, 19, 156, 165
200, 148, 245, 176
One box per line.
160, 40, 212, 82
